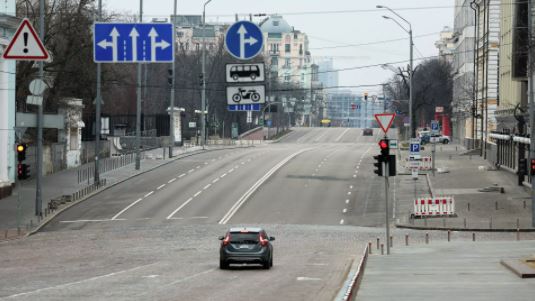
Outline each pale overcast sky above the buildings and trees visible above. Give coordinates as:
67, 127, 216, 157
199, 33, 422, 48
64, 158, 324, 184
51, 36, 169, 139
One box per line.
104, 0, 455, 93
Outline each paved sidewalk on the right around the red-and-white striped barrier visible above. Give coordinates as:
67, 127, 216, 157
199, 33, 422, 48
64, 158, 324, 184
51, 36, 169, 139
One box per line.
396, 144, 534, 231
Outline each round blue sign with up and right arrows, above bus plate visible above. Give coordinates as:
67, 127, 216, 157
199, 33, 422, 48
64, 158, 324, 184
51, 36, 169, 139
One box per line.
225, 21, 264, 60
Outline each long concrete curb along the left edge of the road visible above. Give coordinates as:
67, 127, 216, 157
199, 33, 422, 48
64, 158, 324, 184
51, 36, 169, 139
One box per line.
26, 146, 254, 239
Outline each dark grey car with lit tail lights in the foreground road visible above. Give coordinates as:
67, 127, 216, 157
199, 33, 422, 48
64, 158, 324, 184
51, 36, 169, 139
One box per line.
219, 228, 275, 269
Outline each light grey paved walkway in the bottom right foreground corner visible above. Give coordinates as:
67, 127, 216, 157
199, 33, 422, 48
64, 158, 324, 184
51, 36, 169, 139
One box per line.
356, 241, 535, 301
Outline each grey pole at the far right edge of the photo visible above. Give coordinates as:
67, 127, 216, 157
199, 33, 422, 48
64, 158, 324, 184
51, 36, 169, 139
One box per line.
528, 0, 535, 227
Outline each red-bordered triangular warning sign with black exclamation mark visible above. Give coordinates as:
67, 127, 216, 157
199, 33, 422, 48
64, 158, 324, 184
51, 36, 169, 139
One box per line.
2, 18, 50, 61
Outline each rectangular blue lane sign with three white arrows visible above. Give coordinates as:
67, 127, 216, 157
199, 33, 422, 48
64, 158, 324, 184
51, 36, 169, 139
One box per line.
93, 23, 175, 63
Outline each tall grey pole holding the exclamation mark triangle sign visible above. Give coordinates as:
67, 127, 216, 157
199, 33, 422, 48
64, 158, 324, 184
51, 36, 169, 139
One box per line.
35, 0, 45, 218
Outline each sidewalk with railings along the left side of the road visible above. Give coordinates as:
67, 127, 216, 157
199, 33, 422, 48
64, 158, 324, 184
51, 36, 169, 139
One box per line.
0, 144, 253, 237
